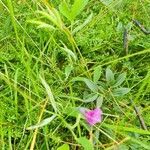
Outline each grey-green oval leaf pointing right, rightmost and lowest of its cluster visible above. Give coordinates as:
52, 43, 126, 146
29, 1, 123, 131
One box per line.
112, 88, 130, 96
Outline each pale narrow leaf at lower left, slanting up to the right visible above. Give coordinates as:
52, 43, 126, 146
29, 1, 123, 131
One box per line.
27, 115, 56, 130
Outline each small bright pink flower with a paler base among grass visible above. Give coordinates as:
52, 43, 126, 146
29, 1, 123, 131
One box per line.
80, 108, 102, 126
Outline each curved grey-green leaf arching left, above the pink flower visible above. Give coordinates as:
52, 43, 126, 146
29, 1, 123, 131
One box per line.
72, 77, 98, 92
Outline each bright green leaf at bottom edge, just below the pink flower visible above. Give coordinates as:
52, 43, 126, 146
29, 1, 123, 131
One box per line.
77, 137, 94, 150
